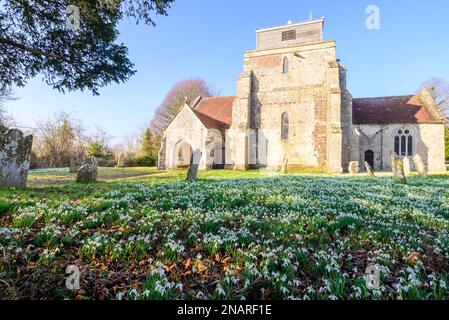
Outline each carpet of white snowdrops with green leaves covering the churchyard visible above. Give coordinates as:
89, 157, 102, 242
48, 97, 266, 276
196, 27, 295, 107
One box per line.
0, 176, 449, 300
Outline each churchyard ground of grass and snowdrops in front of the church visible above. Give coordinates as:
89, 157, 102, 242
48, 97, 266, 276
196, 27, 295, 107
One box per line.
0, 168, 449, 299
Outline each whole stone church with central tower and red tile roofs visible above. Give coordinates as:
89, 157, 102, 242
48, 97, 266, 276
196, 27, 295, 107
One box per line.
159, 19, 445, 173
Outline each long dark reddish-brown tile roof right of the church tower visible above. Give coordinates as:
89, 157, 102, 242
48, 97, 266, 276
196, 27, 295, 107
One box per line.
352, 95, 441, 124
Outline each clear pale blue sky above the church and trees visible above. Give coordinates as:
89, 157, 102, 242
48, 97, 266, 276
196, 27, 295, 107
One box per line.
4, 0, 449, 139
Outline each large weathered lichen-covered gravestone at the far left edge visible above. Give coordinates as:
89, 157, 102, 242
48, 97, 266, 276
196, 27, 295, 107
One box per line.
0, 129, 33, 188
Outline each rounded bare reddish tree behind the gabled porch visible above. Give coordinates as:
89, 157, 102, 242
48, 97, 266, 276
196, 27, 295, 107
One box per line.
150, 79, 215, 136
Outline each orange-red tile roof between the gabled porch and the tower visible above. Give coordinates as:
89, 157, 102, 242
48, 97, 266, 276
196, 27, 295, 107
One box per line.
193, 97, 235, 130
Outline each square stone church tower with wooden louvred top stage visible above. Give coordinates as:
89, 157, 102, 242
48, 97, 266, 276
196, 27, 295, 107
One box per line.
226, 19, 353, 172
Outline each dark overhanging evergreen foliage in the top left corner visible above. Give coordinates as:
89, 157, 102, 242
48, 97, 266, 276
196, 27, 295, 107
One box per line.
0, 0, 174, 95
